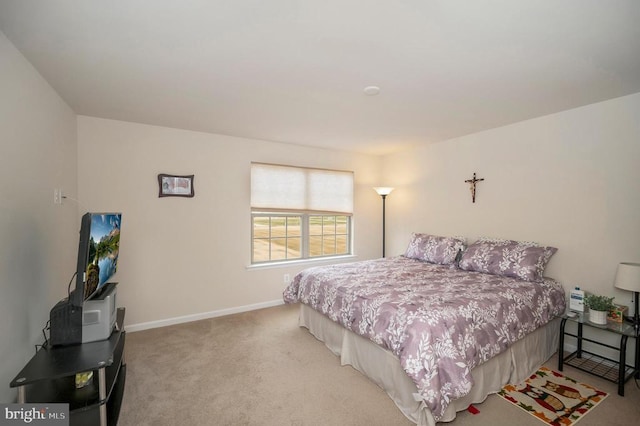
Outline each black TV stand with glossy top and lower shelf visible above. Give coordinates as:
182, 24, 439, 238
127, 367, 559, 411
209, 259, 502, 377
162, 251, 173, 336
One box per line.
10, 308, 127, 426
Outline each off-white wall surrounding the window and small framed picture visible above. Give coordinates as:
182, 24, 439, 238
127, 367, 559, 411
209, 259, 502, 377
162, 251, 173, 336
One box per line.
78, 116, 381, 329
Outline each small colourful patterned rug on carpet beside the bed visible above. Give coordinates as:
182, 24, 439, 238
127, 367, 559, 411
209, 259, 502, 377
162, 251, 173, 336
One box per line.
498, 367, 607, 426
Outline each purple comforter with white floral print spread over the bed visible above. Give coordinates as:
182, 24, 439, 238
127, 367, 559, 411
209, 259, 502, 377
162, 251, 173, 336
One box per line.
284, 256, 565, 420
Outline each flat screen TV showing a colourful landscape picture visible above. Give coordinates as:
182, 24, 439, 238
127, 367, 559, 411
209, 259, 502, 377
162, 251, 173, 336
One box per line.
72, 213, 122, 306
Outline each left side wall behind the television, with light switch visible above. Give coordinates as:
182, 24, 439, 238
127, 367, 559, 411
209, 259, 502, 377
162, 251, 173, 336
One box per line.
0, 32, 78, 402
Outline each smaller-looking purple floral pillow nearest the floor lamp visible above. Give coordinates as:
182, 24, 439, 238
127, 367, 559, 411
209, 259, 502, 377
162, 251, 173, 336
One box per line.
404, 232, 466, 265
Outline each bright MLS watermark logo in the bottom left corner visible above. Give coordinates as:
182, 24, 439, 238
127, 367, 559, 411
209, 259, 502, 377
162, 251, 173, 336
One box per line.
0, 404, 69, 426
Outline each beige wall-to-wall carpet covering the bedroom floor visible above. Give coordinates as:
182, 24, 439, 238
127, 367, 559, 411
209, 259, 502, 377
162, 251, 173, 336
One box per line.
118, 305, 640, 426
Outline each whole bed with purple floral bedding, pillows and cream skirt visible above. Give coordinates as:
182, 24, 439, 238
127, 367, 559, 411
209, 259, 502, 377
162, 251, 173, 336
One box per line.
283, 234, 565, 425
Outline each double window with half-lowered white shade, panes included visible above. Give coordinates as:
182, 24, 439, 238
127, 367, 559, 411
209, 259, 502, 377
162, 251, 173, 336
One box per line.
251, 163, 353, 263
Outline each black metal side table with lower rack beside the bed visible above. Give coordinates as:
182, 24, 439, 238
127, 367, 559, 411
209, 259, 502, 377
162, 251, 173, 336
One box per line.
558, 313, 640, 396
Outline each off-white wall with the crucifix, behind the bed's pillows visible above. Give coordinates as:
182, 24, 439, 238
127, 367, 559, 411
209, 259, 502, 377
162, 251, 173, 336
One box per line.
384, 94, 640, 305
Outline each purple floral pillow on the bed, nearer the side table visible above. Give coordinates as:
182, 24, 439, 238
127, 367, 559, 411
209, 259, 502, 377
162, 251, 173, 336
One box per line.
458, 238, 558, 282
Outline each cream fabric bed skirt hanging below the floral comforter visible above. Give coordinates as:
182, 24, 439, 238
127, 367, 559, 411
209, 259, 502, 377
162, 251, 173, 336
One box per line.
298, 303, 560, 426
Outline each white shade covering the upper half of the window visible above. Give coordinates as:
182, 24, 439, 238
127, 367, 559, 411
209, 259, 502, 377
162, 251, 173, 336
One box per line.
251, 163, 353, 213
